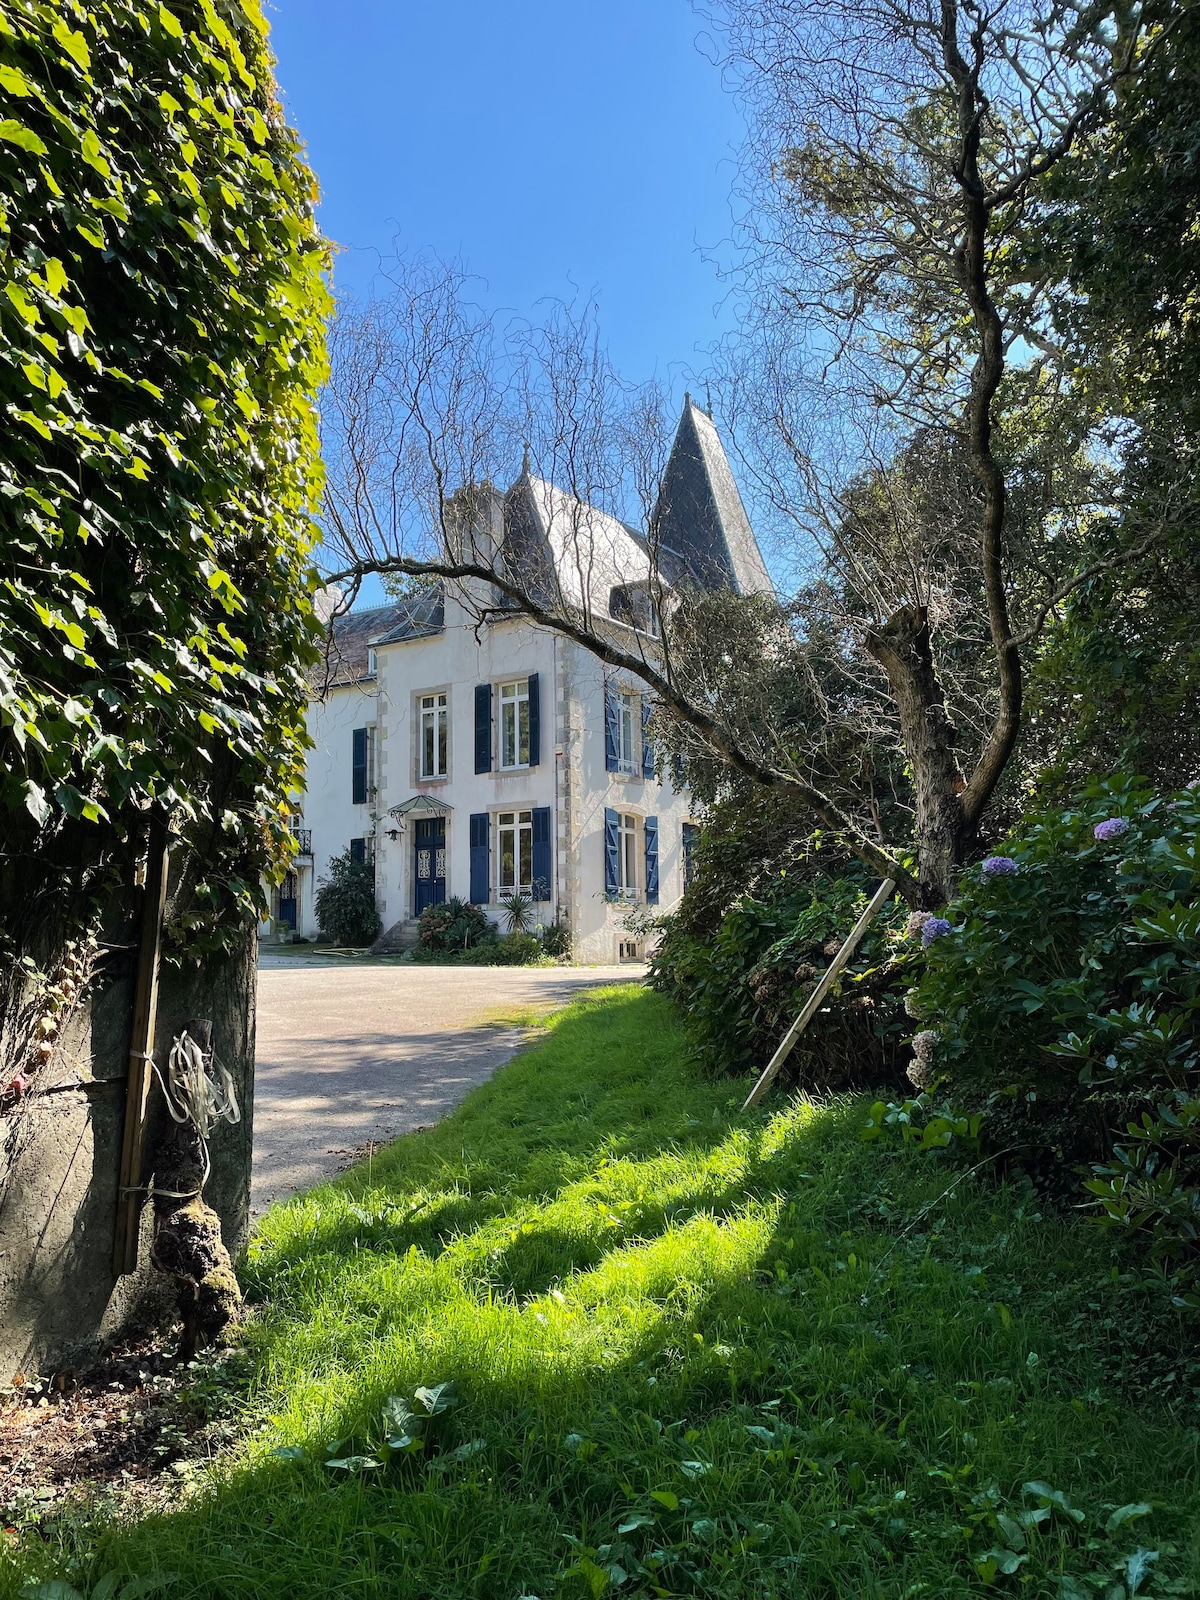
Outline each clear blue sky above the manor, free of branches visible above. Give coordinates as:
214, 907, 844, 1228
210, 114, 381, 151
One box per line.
267, 0, 741, 387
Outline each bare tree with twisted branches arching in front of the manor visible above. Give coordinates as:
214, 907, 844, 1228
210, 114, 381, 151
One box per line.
326, 0, 1154, 906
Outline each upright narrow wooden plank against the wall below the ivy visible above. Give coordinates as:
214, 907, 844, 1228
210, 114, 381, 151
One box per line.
112, 811, 168, 1277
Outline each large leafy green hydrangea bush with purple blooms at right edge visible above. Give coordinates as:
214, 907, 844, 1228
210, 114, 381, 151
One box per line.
915, 779, 1200, 1254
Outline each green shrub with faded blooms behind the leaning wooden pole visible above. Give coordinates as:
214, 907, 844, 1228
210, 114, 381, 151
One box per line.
650, 874, 914, 1088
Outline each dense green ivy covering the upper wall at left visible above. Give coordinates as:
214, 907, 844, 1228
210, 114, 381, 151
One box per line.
0, 0, 326, 941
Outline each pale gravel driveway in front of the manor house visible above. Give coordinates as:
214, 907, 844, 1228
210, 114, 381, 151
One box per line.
251, 950, 645, 1218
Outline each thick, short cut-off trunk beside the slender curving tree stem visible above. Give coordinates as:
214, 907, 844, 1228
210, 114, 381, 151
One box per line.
867, 605, 976, 910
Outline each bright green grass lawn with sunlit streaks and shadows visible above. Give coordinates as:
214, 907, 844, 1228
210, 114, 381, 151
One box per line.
0, 987, 1200, 1600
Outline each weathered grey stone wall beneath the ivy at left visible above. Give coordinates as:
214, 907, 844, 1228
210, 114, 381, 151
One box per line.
0, 930, 256, 1384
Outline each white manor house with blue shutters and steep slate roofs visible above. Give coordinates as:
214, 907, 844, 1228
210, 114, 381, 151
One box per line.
272, 400, 771, 963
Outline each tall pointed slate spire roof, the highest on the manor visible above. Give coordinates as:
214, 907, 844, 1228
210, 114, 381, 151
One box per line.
651, 397, 774, 595
